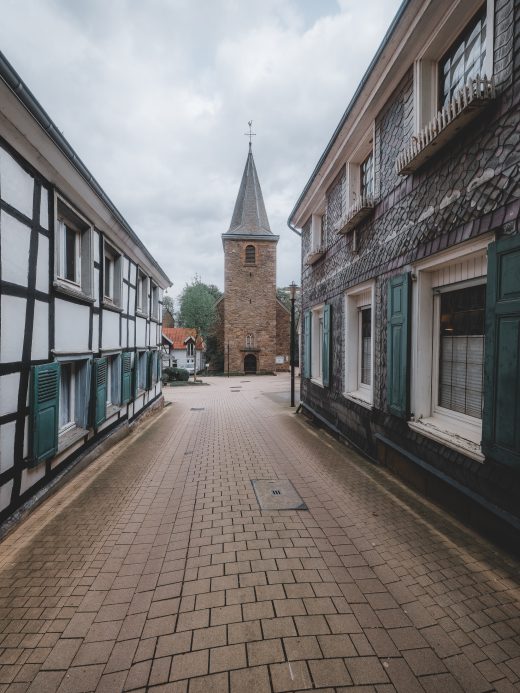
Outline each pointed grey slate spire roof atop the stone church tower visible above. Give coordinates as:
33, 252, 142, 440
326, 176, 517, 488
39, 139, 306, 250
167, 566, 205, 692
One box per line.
222, 145, 277, 240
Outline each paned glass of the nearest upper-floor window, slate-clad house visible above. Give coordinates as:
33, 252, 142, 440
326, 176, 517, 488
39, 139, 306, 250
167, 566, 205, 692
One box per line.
439, 10, 486, 108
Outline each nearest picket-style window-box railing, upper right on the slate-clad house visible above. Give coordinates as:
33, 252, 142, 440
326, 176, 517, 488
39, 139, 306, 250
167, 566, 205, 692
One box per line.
395, 76, 495, 176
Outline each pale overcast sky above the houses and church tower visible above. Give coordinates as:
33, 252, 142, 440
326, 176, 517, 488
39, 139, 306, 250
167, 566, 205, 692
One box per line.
0, 0, 400, 306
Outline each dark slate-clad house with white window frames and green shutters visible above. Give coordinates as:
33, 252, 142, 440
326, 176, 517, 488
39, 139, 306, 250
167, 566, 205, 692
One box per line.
289, 0, 520, 539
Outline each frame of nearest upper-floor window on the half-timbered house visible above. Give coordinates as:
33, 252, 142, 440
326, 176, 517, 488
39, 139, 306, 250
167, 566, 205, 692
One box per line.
54, 194, 94, 298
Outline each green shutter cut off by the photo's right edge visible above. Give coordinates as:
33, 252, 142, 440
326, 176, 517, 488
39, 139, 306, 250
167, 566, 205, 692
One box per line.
482, 235, 520, 466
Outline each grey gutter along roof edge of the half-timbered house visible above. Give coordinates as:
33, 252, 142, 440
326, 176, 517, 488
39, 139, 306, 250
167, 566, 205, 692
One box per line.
0, 51, 172, 286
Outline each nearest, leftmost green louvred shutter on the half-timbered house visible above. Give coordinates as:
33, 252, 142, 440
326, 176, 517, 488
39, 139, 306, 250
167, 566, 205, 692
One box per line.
29, 363, 60, 462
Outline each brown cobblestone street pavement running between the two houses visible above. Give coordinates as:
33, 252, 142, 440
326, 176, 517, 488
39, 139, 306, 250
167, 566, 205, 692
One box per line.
0, 376, 520, 693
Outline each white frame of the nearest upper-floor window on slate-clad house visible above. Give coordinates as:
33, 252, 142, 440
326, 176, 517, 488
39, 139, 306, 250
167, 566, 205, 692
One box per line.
413, 0, 495, 133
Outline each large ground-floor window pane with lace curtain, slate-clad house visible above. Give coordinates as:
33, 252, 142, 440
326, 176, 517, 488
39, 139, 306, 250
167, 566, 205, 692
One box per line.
438, 285, 485, 419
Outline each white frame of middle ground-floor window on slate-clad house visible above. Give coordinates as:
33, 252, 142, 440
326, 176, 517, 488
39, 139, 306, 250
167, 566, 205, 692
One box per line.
343, 281, 375, 407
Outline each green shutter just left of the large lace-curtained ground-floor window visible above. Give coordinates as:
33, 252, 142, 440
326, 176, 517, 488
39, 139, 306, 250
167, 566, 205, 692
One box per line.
386, 273, 410, 418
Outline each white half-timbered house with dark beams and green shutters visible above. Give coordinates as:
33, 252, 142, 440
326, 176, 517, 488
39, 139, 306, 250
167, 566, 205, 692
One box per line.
0, 54, 170, 521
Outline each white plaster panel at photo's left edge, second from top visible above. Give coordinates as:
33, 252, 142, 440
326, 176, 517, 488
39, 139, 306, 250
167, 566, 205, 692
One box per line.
0, 211, 31, 286
